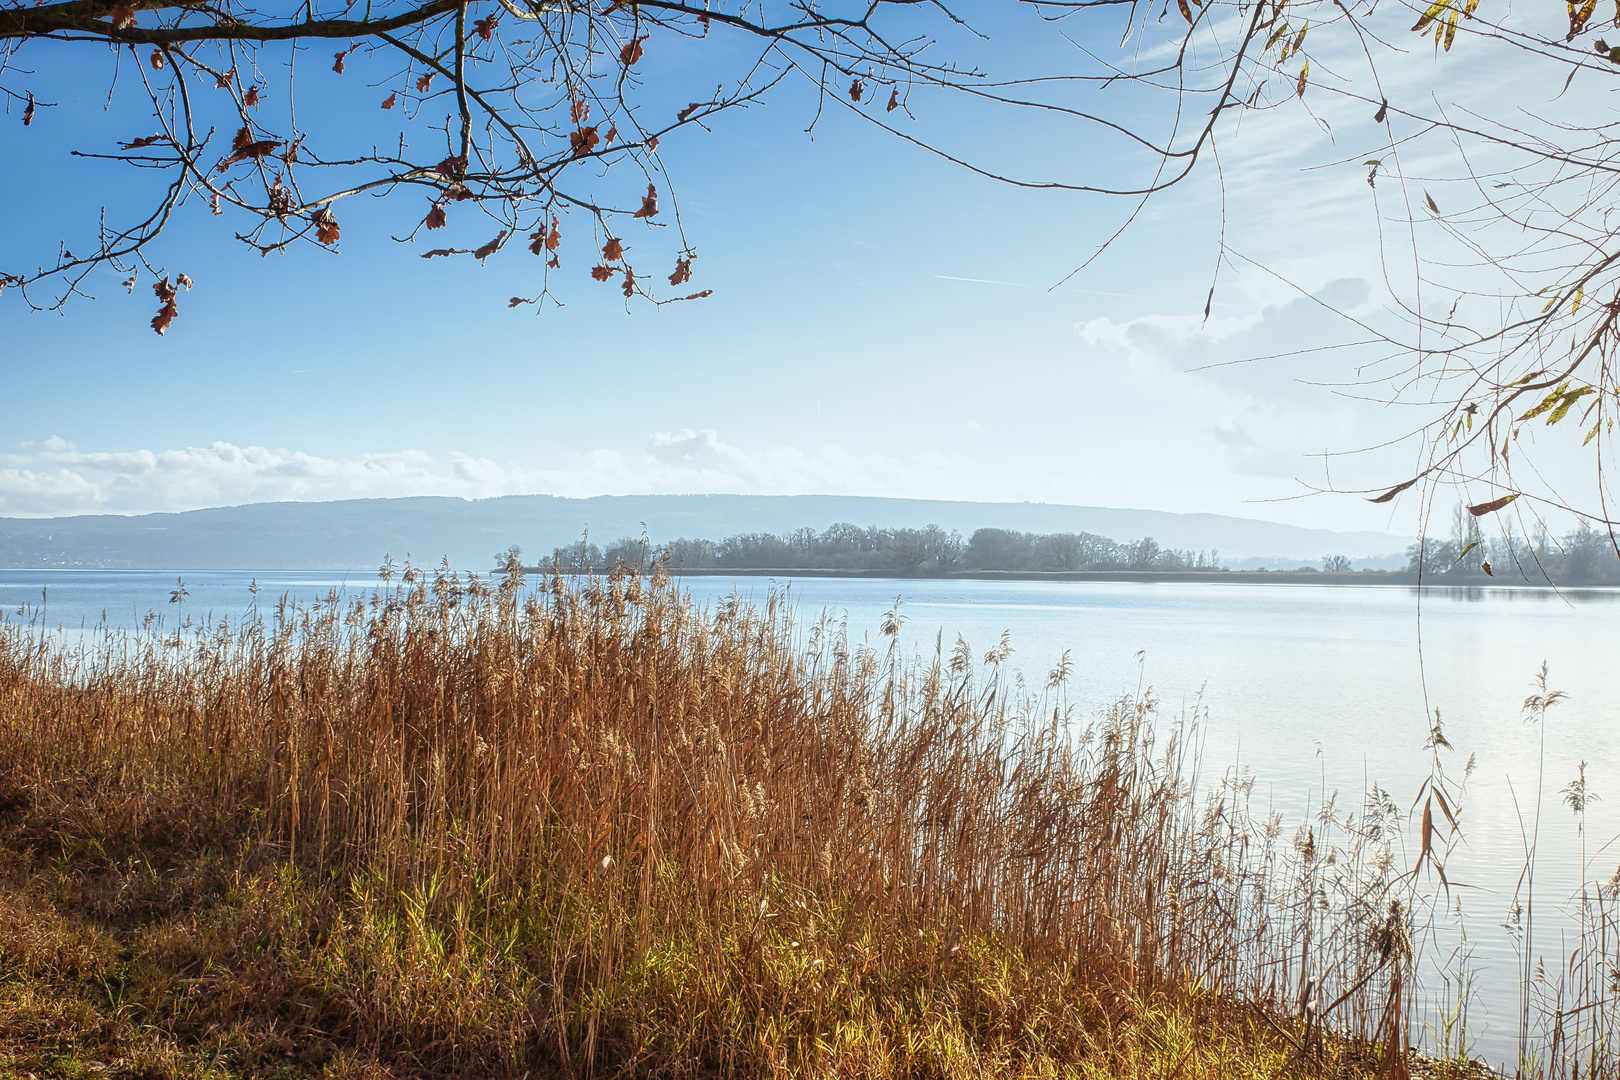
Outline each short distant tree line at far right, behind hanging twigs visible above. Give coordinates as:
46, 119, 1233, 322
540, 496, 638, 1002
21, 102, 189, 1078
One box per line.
1406, 504, 1620, 585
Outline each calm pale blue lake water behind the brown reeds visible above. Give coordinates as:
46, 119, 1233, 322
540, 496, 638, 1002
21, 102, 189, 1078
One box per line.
0, 570, 1620, 1062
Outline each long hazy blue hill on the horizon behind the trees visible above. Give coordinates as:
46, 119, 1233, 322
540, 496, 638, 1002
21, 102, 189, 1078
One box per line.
0, 495, 1406, 570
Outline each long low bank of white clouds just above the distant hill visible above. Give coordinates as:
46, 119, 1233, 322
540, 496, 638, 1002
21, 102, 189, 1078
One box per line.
0, 429, 974, 517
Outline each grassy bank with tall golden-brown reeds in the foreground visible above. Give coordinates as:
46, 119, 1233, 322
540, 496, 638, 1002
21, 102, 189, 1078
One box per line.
0, 572, 1568, 1080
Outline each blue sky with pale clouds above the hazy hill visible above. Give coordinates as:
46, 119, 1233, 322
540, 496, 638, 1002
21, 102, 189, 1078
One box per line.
0, 5, 1594, 533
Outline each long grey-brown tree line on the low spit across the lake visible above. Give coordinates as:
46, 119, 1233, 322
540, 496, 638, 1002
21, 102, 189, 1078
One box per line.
515, 521, 1221, 575
